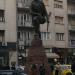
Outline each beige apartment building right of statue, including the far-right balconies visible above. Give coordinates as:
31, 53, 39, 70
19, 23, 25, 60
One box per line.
41, 0, 75, 63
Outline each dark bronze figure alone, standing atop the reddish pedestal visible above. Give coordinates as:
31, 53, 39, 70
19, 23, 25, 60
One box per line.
31, 0, 49, 38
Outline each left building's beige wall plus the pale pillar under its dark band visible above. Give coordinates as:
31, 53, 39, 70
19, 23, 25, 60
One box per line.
0, 0, 17, 64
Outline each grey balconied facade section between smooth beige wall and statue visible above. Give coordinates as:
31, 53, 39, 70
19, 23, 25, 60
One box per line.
16, 0, 34, 65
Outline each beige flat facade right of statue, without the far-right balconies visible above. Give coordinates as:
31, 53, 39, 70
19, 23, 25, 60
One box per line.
41, 0, 68, 62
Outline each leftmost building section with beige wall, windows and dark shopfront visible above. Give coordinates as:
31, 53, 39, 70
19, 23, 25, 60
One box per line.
0, 0, 17, 65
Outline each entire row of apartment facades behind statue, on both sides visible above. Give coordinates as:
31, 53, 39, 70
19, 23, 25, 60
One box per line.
0, 0, 75, 65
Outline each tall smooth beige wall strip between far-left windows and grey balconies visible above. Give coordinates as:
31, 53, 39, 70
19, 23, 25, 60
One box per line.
5, 0, 17, 42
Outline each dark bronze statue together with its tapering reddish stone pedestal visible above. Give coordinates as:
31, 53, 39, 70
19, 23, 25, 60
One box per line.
26, 0, 50, 75
